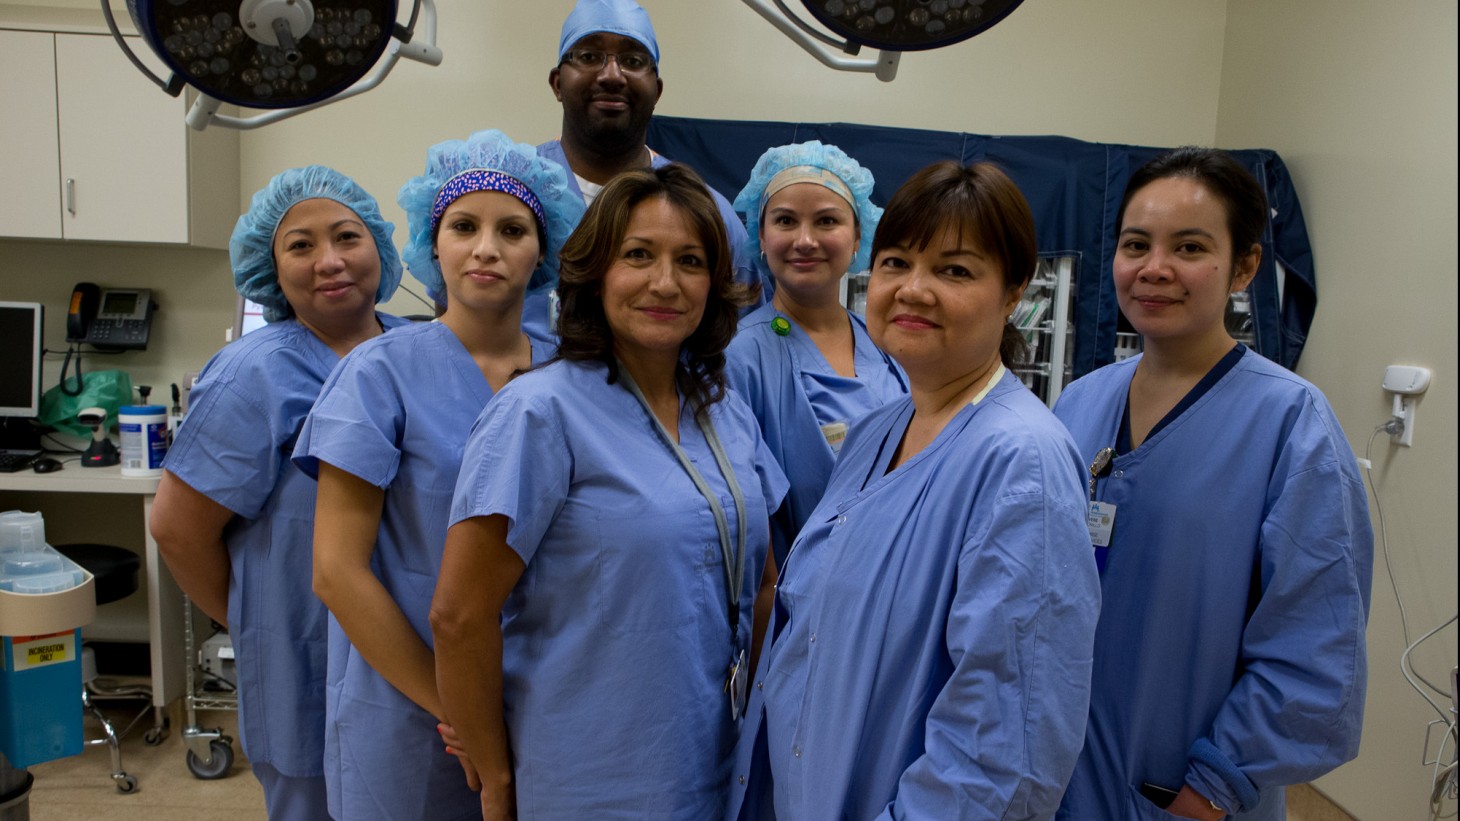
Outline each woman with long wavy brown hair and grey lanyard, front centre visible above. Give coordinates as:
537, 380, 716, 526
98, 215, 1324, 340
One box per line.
431, 164, 785, 821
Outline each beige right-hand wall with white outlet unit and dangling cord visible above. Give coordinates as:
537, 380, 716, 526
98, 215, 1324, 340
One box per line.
1216, 0, 1460, 821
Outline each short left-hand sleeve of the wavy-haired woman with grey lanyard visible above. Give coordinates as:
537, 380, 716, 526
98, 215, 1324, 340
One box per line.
451, 383, 569, 564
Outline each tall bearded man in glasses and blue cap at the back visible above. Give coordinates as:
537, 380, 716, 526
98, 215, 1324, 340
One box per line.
537, 0, 764, 324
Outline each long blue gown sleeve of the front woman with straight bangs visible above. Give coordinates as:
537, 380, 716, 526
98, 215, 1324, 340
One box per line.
880, 488, 1099, 820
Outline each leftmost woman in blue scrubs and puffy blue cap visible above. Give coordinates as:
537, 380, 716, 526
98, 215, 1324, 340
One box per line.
150, 165, 403, 821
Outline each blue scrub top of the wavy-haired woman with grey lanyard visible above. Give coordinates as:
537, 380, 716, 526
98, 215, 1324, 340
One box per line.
451, 361, 785, 821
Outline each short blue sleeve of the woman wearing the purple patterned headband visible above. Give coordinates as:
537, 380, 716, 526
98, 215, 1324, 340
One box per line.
293, 352, 406, 488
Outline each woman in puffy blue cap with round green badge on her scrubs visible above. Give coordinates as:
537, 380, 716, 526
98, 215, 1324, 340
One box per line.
726, 142, 908, 561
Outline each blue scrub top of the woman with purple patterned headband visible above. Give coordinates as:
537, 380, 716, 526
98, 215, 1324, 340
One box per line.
293, 321, 550, 821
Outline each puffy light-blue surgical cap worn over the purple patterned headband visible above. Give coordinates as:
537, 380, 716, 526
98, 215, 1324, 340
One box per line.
396, 130, 584, 305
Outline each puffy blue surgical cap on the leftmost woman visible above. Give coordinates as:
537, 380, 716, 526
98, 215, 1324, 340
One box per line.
228, 165, 400, 321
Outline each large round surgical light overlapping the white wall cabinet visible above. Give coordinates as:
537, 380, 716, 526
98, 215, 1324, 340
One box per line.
102, 0, 441, 130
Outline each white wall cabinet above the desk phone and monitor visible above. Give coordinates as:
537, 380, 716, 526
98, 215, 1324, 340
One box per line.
0, 31, 239, 248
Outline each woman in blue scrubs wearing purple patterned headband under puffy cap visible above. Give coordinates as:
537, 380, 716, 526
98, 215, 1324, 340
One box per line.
295, 131, 583, 821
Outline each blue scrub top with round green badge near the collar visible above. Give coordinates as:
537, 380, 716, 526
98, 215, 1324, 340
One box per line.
726, 305, 908, 562
